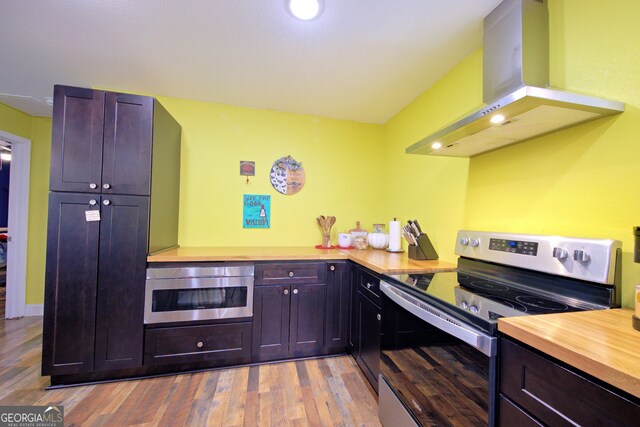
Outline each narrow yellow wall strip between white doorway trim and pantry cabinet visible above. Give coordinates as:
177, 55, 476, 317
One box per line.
0, 104, 51, 304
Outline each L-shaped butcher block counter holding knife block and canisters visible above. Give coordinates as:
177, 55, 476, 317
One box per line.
147, 247, 456, 274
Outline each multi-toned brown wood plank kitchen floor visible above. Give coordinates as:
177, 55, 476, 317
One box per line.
0, 317, 380, 426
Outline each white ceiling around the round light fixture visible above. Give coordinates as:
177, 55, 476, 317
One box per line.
0, 0, 500, 123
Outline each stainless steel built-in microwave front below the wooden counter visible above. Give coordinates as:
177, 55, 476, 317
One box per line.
144, 276, 253, 324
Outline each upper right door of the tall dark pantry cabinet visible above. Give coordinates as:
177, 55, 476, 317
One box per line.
102, 92, 153, 196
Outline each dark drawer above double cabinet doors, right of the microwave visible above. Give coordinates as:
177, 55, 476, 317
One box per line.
255, 262, 326, 285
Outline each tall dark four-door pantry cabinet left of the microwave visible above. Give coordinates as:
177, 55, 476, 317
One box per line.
42, 86, 181, 382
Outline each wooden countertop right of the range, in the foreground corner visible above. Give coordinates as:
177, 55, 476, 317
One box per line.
498, 309, 640, 397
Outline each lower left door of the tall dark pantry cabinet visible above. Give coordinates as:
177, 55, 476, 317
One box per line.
42, 193, 100, 375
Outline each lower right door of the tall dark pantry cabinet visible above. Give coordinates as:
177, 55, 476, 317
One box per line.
95, 195, 149, 370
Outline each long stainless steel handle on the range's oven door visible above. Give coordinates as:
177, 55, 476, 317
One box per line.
380, 281, 498, 357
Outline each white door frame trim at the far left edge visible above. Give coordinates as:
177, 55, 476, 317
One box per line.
0, 130, 31, 319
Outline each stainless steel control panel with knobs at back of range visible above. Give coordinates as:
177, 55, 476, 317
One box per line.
456, 230, 622, 285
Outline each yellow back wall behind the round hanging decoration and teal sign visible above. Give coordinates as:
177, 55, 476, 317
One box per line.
159, 98, 387, 246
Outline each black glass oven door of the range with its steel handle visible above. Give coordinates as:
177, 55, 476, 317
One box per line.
379, 282, 497, 427
